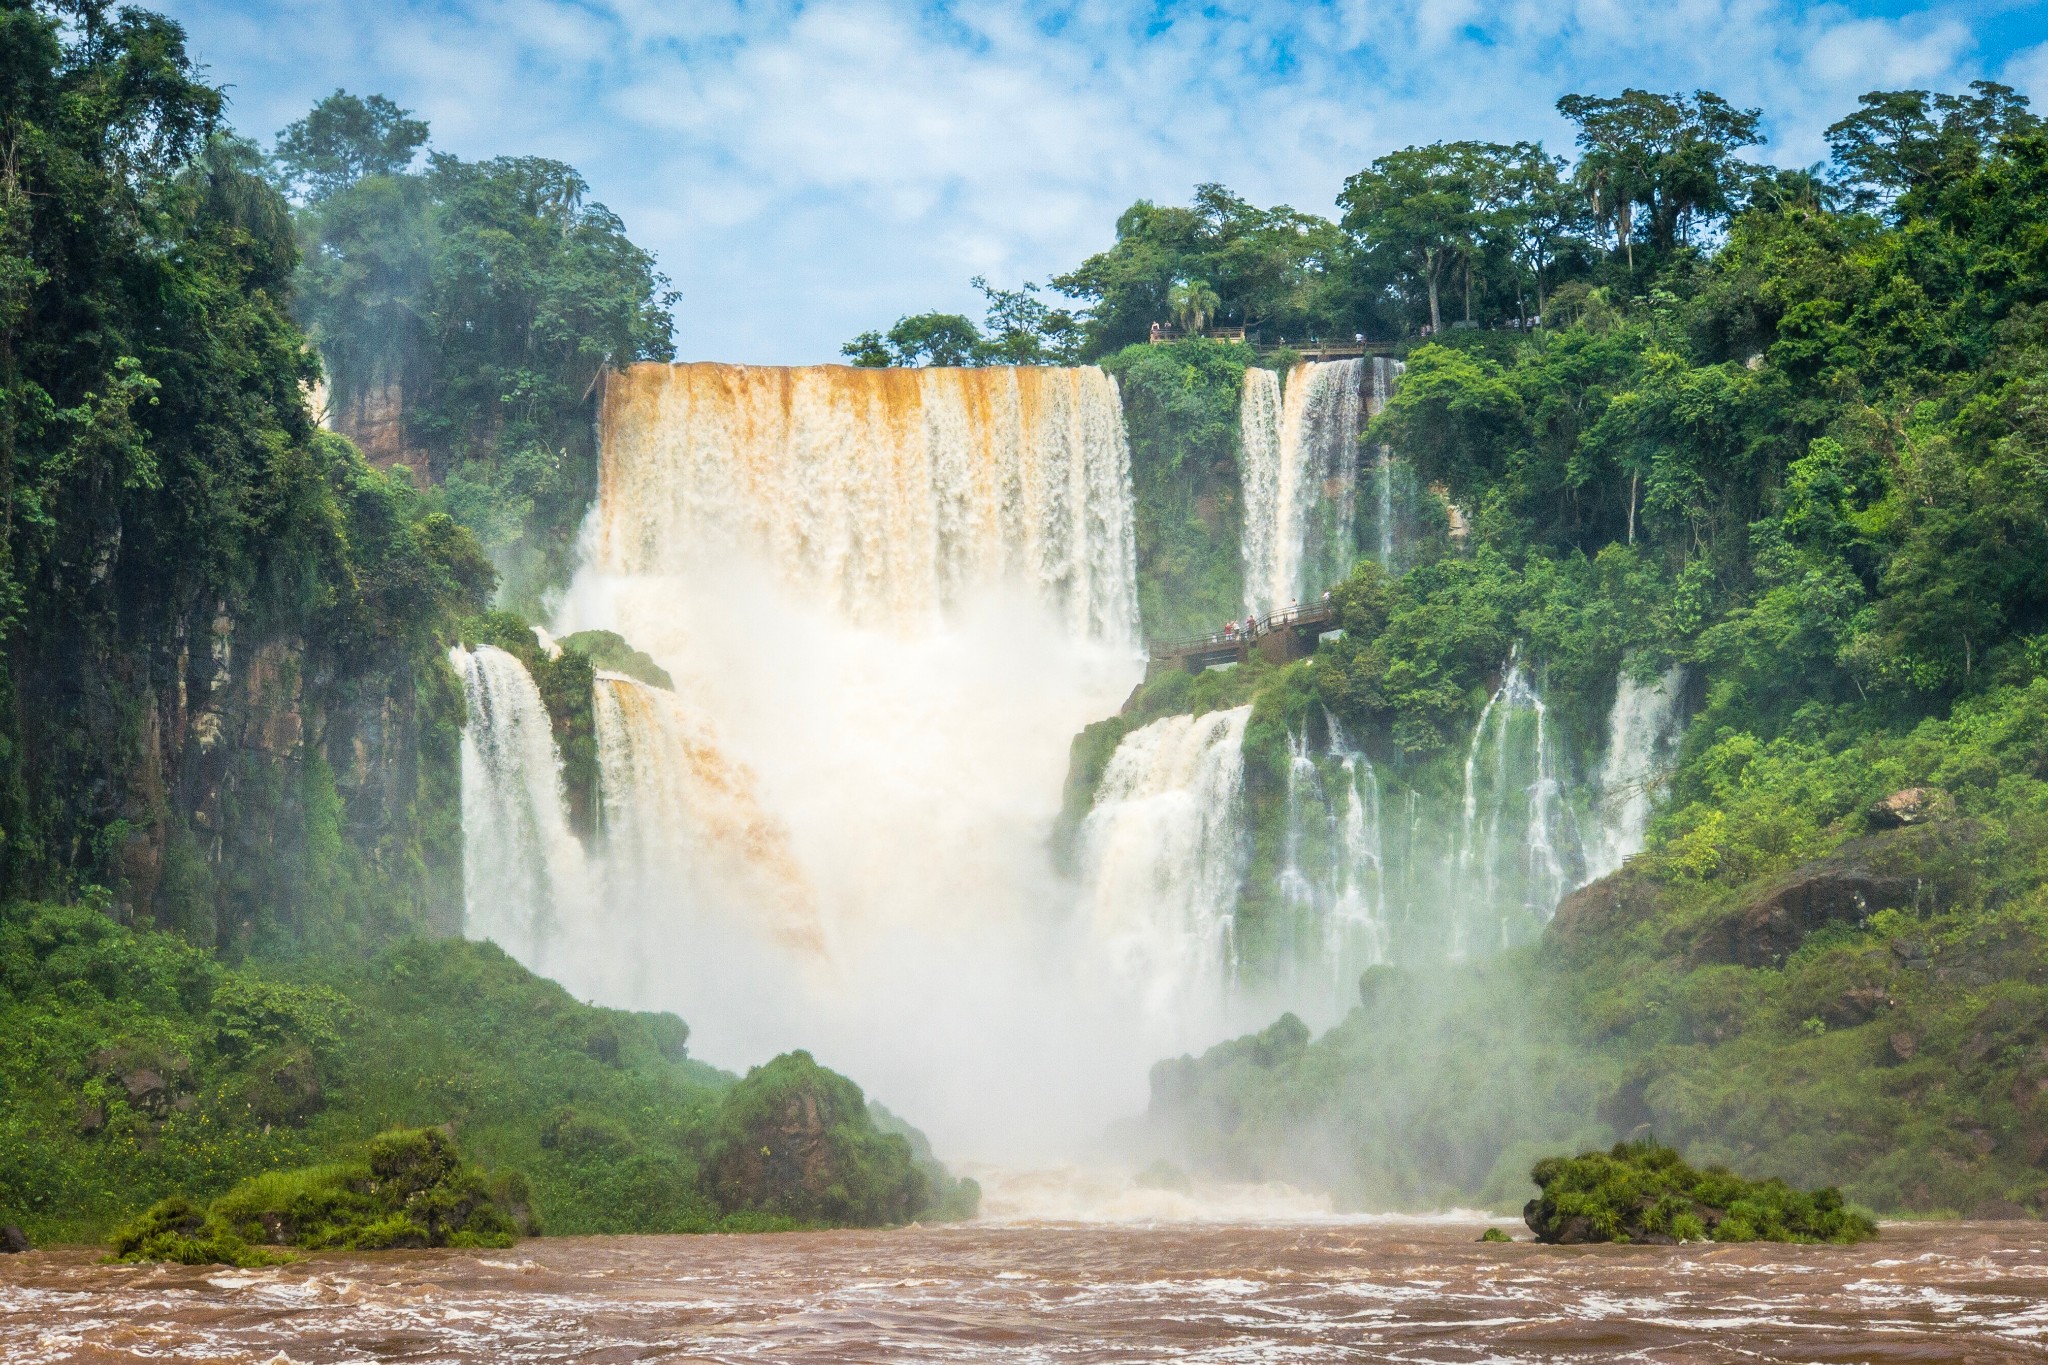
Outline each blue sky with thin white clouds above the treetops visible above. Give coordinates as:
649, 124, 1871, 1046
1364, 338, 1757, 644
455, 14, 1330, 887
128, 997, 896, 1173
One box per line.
150, 0, 2048, 364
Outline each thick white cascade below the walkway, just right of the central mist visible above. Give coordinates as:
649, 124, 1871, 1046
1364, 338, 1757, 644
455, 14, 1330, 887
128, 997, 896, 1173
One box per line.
1081, 706, 1251, 1017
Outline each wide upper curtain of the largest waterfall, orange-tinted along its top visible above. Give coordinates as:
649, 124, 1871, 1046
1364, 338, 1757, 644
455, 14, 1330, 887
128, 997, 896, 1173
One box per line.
594, 364, 1139, 641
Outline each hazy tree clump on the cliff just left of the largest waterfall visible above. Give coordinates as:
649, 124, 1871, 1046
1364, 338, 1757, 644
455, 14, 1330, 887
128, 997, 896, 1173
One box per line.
288, 92, 674, 612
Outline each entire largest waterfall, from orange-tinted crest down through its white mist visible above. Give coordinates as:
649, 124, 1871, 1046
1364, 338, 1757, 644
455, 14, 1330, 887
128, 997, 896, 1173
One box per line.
495, 364, 1163, 1156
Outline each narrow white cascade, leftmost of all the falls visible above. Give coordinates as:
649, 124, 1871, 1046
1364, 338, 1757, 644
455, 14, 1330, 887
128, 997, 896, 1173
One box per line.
449, 645, 598, 976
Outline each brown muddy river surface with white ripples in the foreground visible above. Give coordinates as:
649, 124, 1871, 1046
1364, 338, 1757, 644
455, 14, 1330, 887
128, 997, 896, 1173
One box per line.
0, 1222, 2048, 1365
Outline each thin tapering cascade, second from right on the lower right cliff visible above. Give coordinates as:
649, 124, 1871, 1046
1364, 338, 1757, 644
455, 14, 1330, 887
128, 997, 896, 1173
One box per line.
1448, 657, 1585, 958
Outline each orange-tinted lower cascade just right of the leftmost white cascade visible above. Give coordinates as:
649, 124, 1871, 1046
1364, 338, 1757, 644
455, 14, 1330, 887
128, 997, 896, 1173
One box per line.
594, 671, 823, 954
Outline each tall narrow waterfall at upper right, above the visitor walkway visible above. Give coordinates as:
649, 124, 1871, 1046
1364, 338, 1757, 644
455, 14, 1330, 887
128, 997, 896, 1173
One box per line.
1237, 358, 1401, 616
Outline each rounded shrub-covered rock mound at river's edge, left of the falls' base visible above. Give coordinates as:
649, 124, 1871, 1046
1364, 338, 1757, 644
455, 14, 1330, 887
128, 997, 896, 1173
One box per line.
705, 1052, 979, 1228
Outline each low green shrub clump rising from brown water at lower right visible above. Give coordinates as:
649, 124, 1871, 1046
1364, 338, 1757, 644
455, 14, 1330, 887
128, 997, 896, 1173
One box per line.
1522, 1138, 1878, 1244
